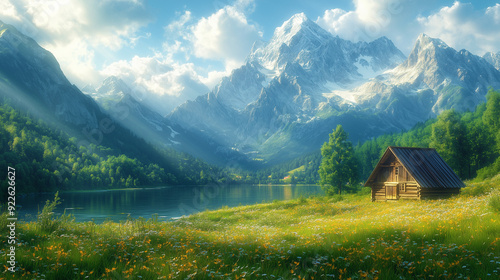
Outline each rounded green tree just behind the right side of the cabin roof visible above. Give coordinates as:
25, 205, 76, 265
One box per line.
429, 109, 470, 178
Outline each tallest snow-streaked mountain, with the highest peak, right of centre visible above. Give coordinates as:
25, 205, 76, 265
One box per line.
169, 14, 405, 162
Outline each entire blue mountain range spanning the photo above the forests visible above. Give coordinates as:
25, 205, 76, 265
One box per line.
4, 10, 500, 167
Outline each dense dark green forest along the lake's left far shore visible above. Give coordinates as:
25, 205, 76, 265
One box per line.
0, 103, 227, 196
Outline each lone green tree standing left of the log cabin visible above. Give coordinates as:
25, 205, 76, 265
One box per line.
318, 125, 358, 195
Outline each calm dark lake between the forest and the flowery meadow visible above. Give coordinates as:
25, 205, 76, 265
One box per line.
16, 185, 323, 223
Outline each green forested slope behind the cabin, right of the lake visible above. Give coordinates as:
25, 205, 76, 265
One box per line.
254, 90, 500, 184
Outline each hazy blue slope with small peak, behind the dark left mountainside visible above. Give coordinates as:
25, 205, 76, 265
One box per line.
84, 76, 249, 167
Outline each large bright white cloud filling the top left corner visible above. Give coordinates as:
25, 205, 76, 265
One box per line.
0, 0, 149, 86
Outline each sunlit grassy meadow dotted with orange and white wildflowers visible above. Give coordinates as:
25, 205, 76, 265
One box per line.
0, 176, 500, 279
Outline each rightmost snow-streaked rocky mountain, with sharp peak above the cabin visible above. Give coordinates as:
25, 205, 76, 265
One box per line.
353, 34, 500, 124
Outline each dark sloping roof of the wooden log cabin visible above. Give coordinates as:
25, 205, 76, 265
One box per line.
365, 146, 465, 188
